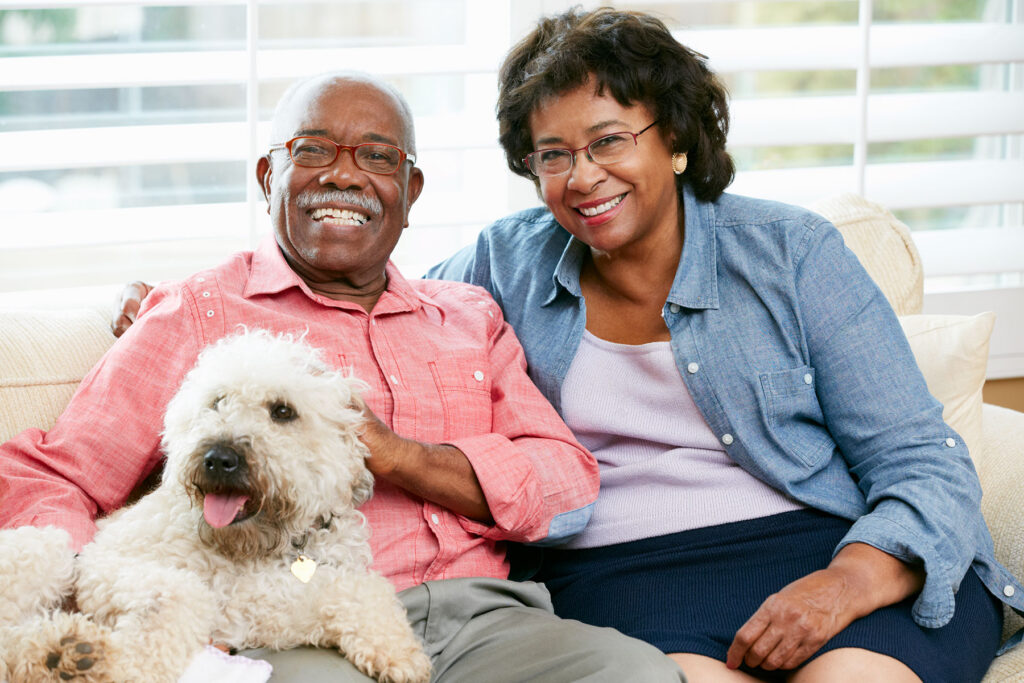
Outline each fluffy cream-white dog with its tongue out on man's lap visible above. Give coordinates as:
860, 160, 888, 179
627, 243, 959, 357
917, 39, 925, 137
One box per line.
0, 331, 430, 683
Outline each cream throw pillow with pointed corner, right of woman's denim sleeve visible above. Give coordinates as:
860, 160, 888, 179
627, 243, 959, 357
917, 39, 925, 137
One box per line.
899, 312, 995, 466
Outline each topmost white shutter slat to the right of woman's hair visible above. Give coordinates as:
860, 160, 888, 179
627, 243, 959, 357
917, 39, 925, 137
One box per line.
673, 24, 1024, 73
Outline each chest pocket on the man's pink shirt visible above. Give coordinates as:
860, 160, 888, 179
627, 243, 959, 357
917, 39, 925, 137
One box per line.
429, 350, 493, 439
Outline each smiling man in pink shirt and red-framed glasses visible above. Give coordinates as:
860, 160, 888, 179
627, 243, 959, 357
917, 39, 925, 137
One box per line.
0, 75, 683, 683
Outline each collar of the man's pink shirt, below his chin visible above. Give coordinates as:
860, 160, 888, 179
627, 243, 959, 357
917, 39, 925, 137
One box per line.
243, 236, 444, 317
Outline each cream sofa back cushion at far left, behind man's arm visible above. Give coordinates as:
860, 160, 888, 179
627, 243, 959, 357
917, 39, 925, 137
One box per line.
0, 308, 114, 442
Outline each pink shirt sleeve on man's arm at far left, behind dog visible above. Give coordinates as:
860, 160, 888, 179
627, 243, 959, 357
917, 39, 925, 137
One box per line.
0, 290, 198, 550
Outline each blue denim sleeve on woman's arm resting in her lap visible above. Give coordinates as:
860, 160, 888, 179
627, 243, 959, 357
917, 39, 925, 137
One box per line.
797, 222, 984, 628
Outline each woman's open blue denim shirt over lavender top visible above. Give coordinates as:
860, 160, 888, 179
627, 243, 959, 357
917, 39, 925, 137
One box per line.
428, 187, 1024, 646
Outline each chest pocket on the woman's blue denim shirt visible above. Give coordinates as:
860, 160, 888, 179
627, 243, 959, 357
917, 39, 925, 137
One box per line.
758, 366, 836, 467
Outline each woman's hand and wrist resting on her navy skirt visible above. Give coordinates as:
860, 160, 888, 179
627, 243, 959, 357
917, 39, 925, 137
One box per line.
725, 543, 925, 671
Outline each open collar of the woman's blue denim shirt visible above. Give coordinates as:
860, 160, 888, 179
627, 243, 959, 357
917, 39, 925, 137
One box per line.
542, 184, 718, 308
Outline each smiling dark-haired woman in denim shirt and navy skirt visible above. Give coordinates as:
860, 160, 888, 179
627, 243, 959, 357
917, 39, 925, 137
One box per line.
430, 9, 1024, 683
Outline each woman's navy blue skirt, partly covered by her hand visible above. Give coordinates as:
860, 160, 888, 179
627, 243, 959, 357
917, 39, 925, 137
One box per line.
537, 510, 1002, 683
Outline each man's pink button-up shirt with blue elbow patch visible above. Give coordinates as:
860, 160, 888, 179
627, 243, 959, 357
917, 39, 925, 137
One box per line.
0, 240, 599, 590
